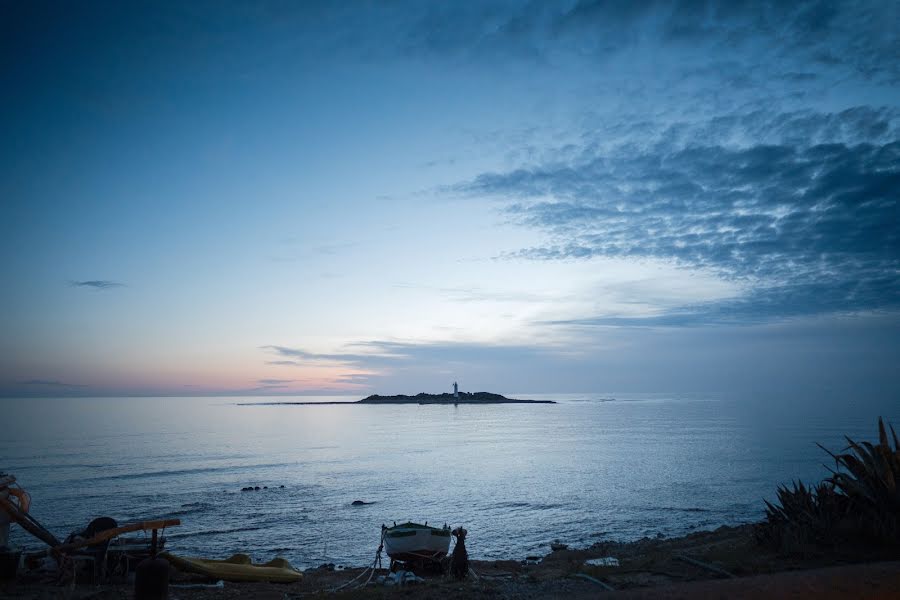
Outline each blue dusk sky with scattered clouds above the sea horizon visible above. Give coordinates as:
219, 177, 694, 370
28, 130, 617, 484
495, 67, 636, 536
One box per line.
0, 0, 900, 400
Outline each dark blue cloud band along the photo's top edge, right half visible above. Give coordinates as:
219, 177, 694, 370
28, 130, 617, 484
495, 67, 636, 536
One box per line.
390, 0, 900, 81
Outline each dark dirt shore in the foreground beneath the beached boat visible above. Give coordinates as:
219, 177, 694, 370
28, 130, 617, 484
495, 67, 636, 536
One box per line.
0, 525, 900, 600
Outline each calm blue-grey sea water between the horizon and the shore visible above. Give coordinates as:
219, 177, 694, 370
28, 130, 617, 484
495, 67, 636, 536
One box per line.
0, 394, 900, 567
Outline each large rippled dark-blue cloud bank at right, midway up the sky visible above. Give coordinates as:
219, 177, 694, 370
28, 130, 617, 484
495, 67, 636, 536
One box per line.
455, 107, 900, 323
